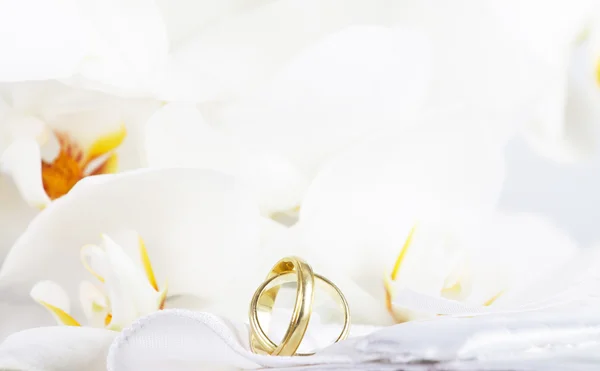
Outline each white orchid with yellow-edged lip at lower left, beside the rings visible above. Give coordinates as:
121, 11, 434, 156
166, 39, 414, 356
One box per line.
0, 169, 264, 369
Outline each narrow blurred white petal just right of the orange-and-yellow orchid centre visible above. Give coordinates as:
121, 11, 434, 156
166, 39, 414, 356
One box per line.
146, 104, 308, 215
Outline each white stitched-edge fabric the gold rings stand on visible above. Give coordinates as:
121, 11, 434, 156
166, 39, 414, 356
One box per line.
108, 310, 600, 371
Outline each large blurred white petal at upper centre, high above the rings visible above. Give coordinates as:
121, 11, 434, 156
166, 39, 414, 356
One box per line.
214, 26, 430, 178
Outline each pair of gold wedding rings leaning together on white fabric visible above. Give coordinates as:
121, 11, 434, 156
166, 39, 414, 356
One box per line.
249, 257, 350, 356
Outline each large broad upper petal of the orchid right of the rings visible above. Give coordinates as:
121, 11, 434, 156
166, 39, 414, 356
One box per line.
262, 116, 504, 324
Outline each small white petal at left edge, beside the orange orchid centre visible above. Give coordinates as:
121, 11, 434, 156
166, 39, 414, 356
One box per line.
0, 138, 50, 209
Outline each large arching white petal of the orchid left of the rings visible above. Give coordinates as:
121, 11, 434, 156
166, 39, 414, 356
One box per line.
0, 169, 260, 317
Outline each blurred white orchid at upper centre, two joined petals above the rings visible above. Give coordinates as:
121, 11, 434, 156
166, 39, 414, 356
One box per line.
146, 26, 429, 215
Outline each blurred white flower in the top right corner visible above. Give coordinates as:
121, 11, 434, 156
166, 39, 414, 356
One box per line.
489, 0, 600, 161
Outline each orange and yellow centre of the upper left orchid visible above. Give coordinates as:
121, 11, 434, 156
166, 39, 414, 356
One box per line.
42, 126, 127, 200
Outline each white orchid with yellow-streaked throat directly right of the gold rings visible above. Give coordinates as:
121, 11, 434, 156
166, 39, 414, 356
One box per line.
256, 119, 596, 325
